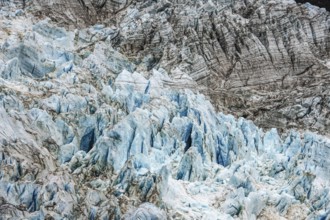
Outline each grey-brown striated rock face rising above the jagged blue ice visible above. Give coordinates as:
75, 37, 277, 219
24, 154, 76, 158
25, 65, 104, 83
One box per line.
32, 0, 330, 133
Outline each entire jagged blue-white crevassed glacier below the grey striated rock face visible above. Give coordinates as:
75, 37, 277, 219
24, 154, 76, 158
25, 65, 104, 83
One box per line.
0, 0, 330, 220
